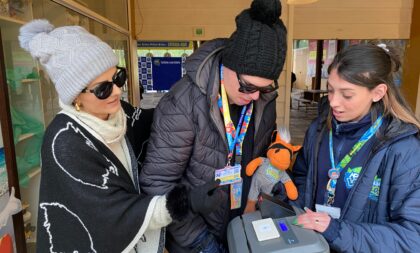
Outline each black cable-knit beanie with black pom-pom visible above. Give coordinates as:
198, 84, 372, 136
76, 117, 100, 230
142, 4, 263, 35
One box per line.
222, 0, 287, 80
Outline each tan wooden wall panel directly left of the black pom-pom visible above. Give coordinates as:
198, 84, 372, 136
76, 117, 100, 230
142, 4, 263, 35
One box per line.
135, 0, 251, 40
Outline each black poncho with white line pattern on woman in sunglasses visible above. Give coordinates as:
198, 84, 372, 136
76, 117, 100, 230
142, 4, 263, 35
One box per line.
37, 103, 163, 252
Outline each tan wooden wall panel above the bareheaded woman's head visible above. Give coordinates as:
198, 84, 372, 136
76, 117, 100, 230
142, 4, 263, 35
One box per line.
293, 0, 413, 39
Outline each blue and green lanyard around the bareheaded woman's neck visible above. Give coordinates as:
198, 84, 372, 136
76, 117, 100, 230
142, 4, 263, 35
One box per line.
327, 116, 382, 206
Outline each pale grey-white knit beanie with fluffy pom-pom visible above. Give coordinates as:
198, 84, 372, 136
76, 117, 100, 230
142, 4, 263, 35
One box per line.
19, 19, 118, 105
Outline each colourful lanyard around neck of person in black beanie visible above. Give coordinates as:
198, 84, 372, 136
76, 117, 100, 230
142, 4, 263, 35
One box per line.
218, 65, 253, 166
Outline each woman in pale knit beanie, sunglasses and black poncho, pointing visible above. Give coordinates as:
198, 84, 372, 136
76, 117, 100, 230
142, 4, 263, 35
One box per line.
19, 20, 221, 252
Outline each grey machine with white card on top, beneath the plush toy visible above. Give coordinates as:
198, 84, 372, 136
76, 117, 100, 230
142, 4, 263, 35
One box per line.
227, 195, 330, 253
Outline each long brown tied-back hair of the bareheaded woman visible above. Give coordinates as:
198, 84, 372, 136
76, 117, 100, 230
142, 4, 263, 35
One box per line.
327, 44, 420, 129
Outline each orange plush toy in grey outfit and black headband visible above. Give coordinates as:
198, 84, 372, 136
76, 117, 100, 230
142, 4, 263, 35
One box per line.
244, 127, 301, 213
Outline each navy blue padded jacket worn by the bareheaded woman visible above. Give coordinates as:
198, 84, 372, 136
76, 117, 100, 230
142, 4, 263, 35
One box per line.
293, 111, 420, 252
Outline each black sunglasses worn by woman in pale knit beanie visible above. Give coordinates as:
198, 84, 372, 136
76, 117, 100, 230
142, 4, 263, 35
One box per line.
81, 67, 127, 99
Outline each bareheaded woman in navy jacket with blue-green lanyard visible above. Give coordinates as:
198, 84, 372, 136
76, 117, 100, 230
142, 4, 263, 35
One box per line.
293, 44, 420, 252
